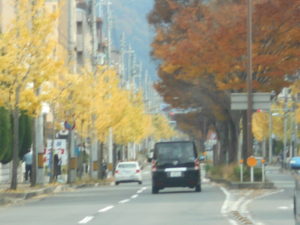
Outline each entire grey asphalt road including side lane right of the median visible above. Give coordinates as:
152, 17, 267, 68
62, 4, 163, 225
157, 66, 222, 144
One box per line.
0, 164, 294, 225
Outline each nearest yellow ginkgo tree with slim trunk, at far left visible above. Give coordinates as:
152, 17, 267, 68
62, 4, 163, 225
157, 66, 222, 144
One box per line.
0, 0, 59, 189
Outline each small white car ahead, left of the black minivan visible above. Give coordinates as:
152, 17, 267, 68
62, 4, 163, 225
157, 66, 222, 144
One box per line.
115, 162, 142, 185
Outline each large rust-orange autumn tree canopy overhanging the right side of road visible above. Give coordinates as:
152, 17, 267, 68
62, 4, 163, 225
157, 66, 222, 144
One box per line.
148, 0, 300, 160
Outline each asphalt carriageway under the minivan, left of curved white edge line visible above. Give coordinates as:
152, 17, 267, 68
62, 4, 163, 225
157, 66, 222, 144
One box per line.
0, 167, 230, 225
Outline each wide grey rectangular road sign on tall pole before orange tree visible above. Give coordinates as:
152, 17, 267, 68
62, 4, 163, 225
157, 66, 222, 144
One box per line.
231, 92, 271, 110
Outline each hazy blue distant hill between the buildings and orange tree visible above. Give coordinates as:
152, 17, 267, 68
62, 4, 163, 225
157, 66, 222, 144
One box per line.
111, 0, 157, 80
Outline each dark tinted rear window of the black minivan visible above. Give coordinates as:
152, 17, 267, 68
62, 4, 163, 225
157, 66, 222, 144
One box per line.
154, 142, 196, 163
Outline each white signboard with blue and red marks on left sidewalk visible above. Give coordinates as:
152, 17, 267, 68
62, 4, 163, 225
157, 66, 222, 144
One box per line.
44, 139, 68, 166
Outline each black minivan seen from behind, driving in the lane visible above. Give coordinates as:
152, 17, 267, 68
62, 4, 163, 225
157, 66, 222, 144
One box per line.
152, 141, 201, 194
